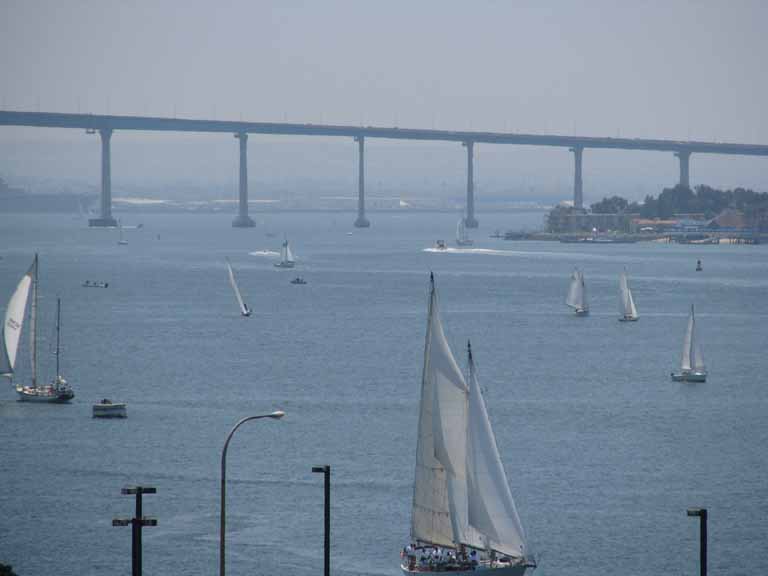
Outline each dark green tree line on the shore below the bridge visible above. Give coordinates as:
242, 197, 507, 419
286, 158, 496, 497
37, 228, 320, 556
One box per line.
590, 184, 768, 219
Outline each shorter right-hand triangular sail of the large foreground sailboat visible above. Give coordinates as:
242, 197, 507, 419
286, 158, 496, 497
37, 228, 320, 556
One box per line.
467, 354, 525, 556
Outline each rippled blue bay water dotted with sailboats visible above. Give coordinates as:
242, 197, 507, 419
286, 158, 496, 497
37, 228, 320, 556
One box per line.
0, 213, 768, 576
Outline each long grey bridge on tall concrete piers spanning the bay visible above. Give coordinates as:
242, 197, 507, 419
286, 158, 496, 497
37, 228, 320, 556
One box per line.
0, 110, 768, 228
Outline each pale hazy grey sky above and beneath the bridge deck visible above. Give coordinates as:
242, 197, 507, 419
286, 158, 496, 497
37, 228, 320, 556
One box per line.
0, 0, 768, 196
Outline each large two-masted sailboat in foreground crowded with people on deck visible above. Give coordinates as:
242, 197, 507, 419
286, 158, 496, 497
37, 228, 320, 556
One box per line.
401, 275, 534, 576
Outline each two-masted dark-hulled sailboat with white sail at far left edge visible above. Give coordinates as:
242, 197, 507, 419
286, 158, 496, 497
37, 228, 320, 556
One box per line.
0, 254, 75, 403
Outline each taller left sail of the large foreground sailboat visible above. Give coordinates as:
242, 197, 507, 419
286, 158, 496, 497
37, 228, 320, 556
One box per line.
411, 278, 482, 547
